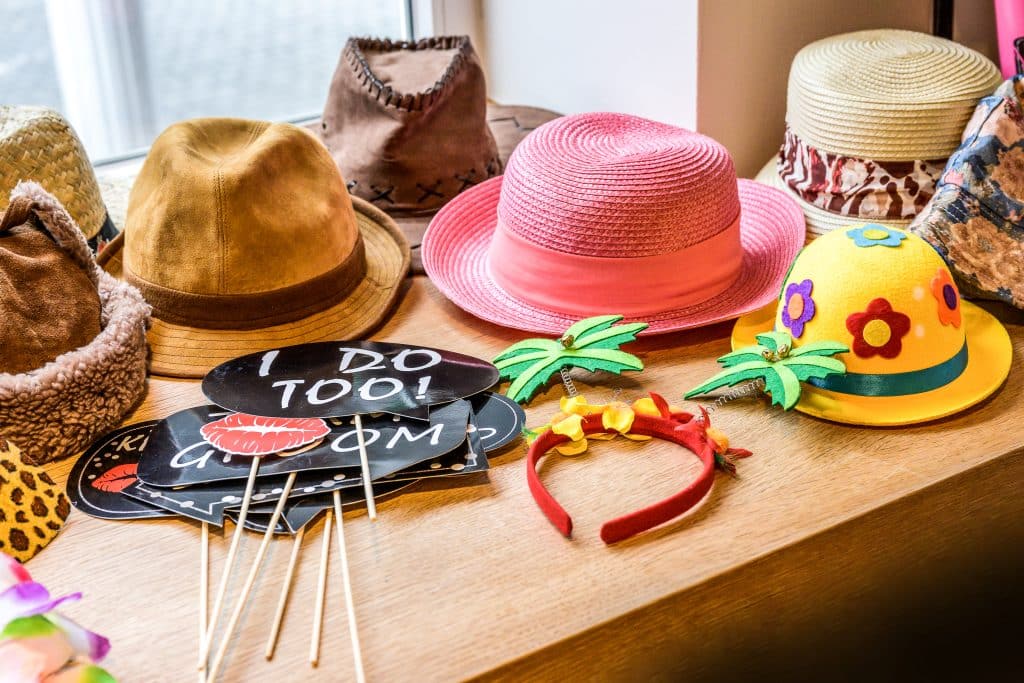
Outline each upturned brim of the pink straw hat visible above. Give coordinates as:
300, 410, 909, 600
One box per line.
422, 176, 804, 335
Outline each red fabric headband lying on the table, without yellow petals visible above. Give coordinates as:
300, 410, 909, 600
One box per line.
526, 394, 751, 544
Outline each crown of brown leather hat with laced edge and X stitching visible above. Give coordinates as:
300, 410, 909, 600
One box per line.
318, 36, 502, 215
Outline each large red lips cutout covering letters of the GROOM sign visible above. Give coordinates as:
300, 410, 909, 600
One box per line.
200, 413, 331, 456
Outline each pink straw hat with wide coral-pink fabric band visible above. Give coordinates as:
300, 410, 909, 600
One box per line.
422, 114, 805, 334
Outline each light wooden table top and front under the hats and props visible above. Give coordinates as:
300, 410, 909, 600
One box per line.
30, 278, 1024, 683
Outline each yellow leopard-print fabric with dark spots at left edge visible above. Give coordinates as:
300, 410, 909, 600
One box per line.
0, 443, 71, 562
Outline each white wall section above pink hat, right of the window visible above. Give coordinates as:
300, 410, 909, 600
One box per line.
477, 0, 697, 128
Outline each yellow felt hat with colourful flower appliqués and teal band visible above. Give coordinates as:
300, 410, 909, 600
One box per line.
732, 223, 1013, 426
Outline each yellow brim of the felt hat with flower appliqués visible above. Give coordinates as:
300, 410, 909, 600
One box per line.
732, 301, 1014, 427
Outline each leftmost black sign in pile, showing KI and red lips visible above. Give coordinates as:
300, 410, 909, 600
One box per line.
68, 420, 172, 519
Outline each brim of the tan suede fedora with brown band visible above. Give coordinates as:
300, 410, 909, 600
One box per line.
100, 197, 410, 378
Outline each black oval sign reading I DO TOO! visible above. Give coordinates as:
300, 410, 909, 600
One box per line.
203, 341, 498, 418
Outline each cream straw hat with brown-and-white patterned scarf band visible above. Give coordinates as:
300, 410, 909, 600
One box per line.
757, 30, 1000, 240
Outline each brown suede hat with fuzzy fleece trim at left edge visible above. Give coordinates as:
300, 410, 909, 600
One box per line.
0, 182, 150, 465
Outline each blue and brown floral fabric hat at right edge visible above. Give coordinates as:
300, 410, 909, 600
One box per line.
910, 76, 1024, 308
